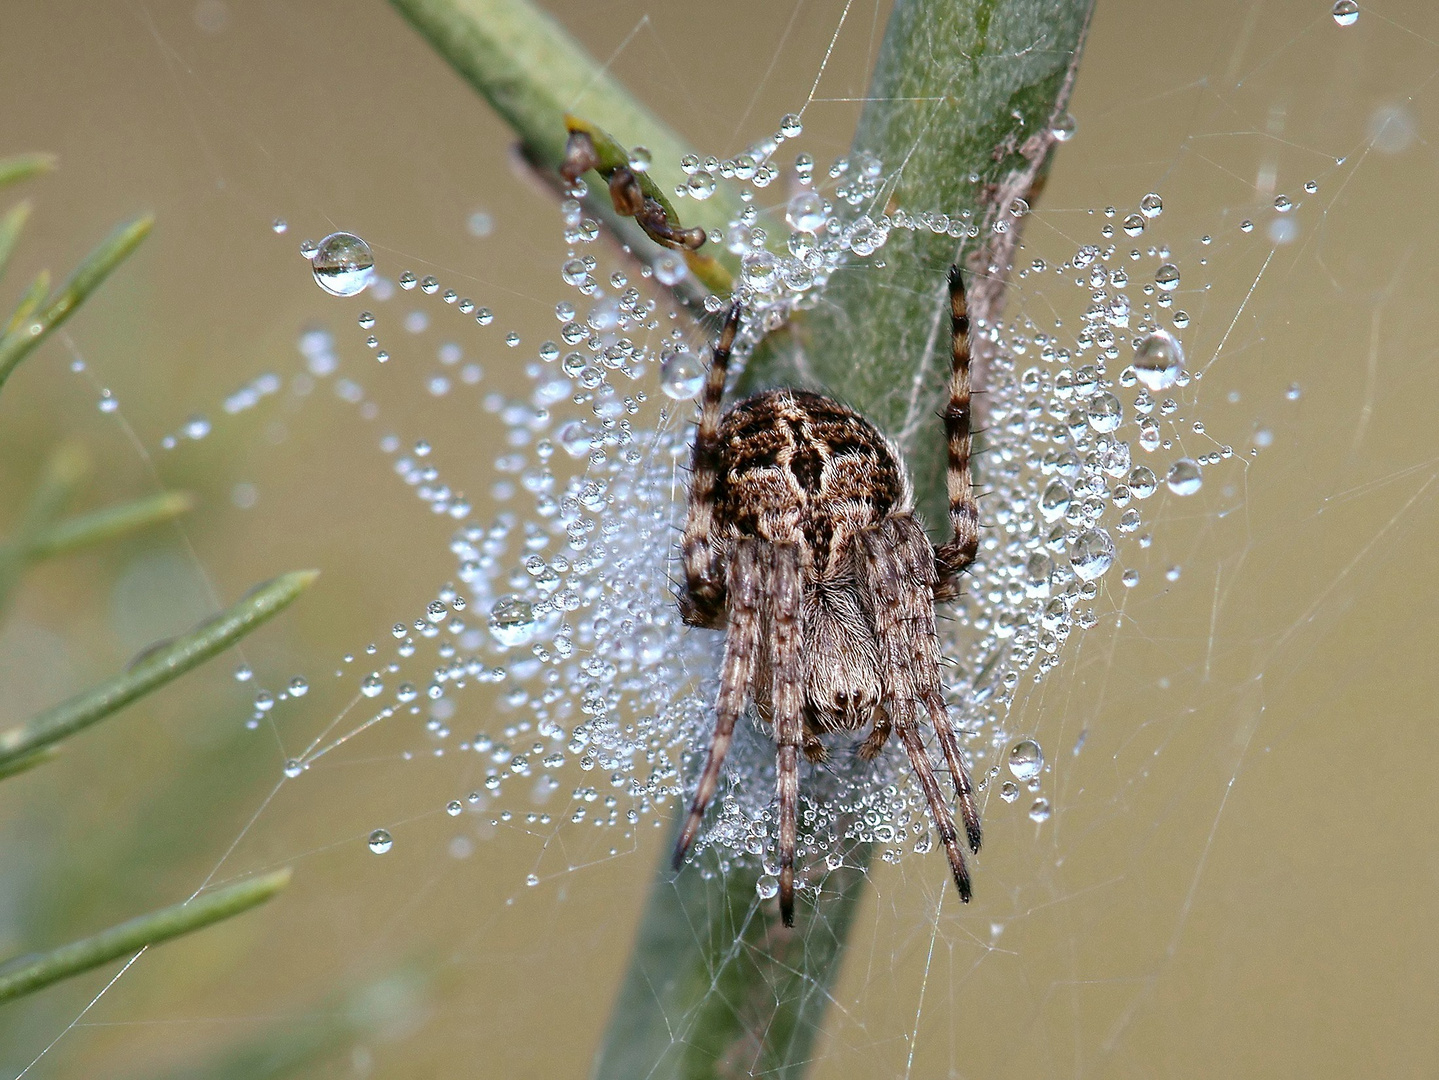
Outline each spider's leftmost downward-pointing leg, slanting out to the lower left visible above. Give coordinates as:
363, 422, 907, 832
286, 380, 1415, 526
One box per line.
673, 539, 764, 870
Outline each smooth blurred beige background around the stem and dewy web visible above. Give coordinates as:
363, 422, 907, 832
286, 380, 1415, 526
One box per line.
0, 0, 1439, 1077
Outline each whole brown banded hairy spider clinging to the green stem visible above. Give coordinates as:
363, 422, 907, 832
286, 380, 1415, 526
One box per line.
675, 267, 980, 926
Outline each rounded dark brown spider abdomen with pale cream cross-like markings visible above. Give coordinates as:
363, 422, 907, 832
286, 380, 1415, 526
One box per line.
715, 390, 911, 580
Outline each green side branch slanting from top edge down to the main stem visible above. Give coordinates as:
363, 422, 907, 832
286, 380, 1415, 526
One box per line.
391, 0, 743, 287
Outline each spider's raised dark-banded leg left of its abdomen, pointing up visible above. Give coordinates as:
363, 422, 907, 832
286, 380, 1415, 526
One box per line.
681, 301, 740, 627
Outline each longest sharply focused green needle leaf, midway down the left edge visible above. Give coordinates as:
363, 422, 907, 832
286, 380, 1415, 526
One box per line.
0, 569, 318, 768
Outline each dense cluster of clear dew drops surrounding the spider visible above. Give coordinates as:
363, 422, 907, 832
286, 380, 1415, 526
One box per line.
235, 110, 1318, 894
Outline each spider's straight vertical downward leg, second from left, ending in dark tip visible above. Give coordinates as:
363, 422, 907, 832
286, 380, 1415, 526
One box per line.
768, 544, 804, 926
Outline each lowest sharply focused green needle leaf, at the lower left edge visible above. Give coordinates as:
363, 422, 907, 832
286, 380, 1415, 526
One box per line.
0, 869, 289, 1004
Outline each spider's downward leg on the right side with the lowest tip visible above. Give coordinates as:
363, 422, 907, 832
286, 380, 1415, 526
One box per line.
858, 515, 979, 903
